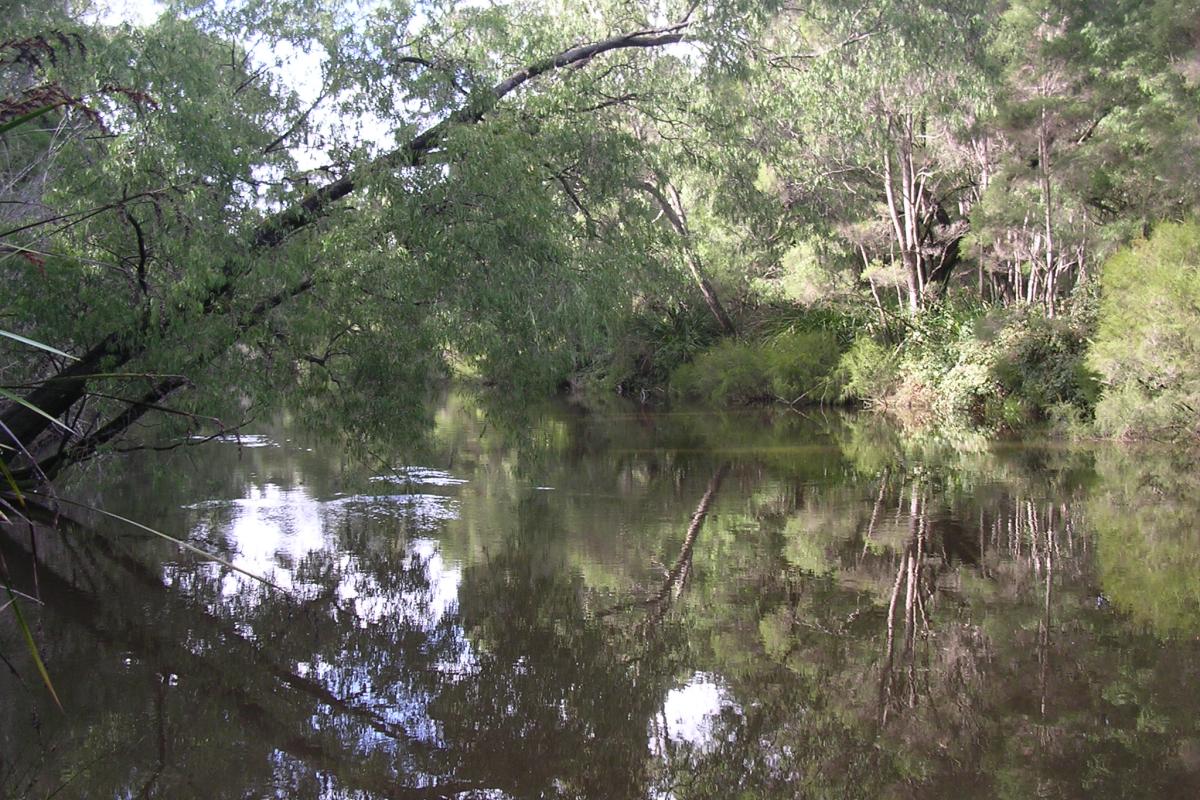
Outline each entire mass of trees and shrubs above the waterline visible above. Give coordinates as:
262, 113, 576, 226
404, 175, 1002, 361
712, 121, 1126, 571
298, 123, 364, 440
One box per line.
0, 0, 1200, 494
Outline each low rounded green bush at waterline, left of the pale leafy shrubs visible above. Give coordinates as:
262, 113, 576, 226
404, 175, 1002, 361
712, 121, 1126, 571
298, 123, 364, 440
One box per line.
671, 331, 840, 404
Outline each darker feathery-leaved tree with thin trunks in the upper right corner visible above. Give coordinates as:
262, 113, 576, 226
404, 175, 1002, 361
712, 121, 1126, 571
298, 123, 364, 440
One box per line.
972, 0, 1200, 315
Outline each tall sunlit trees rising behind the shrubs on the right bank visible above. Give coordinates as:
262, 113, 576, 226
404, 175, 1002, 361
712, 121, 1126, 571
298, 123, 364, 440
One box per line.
705, 0, 1200, 315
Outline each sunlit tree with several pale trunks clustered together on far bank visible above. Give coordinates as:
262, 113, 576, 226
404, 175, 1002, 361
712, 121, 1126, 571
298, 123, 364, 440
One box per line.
750, 1, 990, 312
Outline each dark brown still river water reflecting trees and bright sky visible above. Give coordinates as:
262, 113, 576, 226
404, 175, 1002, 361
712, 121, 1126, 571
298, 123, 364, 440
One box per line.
0, 399, 1200, 799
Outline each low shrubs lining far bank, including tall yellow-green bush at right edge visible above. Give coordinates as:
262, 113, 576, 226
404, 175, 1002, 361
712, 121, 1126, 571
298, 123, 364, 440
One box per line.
595, 215, 1200, 440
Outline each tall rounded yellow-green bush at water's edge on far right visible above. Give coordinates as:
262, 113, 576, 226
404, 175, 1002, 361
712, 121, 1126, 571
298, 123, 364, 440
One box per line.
1088, 222, 1200, 439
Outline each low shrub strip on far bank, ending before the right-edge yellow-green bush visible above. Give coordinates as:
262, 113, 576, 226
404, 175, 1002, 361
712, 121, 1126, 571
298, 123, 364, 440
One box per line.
588, 291, 1100, 434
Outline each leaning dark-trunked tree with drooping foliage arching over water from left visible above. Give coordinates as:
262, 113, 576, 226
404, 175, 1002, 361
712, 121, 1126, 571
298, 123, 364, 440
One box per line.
0, 0, 758, 476
